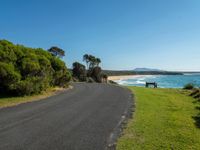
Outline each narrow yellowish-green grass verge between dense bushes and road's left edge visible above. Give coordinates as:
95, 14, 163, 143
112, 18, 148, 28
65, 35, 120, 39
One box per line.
0, 87, 69, 108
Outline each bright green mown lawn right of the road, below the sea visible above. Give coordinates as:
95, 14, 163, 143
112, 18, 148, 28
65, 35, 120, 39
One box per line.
117, 87, 200, 150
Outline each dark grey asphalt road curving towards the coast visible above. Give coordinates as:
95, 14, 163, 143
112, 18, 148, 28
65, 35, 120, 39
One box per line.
0, 83, 132, 150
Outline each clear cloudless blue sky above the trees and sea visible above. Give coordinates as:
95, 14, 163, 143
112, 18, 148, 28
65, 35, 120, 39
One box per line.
0, 0, 200, 71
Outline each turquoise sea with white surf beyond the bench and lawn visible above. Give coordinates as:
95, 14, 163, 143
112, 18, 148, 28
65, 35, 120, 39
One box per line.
116, 73, 200, 88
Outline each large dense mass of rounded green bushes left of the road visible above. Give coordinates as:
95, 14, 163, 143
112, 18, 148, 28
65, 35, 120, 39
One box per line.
0, 40, 71, 95
